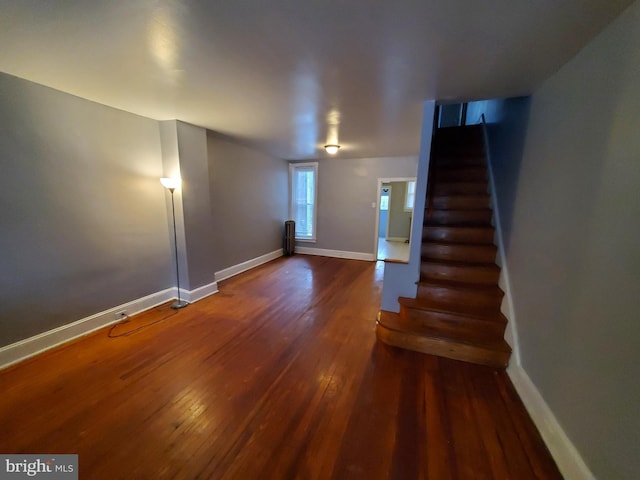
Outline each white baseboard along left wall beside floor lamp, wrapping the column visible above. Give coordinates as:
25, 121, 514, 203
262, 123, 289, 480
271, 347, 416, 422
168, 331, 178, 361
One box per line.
0, 282, 218, 369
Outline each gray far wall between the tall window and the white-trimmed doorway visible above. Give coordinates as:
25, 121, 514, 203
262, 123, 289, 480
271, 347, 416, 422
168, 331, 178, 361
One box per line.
297, 157, 418, 254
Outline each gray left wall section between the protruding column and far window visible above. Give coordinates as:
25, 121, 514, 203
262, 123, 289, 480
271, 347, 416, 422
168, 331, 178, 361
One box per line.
207, 131, 289, 271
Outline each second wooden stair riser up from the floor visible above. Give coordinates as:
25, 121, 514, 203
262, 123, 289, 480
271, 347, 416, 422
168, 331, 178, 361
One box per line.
400, 307, 506, 342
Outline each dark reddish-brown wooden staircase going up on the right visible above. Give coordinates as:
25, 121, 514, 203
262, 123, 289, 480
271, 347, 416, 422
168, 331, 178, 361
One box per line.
376, 126, 511, 367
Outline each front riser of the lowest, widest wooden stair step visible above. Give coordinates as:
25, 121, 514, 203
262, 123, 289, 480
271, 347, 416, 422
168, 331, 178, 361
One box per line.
376, 324, 510, 368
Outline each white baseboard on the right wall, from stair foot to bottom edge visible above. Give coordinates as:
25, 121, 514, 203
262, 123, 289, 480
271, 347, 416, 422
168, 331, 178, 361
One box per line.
507, 364, 596, 480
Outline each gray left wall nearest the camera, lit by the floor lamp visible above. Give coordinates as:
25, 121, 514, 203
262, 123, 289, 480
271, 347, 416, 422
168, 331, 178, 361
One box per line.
0, 73, 173, 345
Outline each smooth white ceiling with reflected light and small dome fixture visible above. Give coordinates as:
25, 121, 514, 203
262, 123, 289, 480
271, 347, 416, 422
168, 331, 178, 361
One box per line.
0, 0, 631, 159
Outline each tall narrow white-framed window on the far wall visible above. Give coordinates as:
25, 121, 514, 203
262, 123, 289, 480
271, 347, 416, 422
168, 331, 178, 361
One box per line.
289, 162, 318, 242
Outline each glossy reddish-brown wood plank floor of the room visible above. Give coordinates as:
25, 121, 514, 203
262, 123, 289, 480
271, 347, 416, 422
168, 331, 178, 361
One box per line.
0, 255, 561, 480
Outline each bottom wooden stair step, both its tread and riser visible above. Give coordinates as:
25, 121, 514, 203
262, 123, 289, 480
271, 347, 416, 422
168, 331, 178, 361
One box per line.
376, 310, 511, 368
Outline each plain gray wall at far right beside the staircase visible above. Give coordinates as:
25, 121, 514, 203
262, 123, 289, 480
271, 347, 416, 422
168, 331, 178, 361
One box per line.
507, 2, 640, 479
